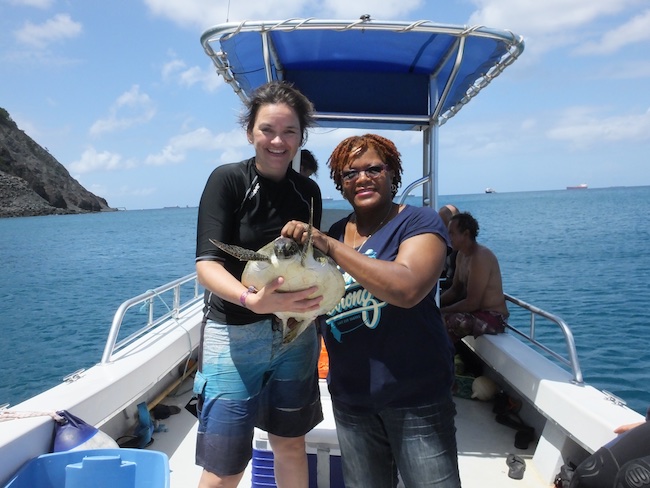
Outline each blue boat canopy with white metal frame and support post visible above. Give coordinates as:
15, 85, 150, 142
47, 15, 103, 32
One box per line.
201, 16, 524, 207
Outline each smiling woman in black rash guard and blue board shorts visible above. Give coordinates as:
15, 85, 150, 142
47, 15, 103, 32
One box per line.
194, 82, 323, 488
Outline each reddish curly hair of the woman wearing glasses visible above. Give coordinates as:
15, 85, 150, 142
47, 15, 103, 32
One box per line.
327, 134, 402, 197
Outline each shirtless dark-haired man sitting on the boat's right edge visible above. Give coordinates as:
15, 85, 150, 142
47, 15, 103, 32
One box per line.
440, 212, 510, 343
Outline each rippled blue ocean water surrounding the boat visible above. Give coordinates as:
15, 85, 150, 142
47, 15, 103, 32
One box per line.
0, 187, 650, 413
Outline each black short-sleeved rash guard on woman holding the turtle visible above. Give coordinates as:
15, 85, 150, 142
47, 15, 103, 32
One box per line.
196, 158, 322, 325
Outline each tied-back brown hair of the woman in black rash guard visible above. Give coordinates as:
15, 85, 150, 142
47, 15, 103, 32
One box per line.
240, 81, 314, 144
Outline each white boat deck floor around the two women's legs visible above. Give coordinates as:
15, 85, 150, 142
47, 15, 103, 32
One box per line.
144, 382, 550, 488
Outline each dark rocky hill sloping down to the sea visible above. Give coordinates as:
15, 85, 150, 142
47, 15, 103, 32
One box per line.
0, 107, 114, 221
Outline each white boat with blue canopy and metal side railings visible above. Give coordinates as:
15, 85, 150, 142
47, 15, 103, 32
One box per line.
0, 16, 643, 488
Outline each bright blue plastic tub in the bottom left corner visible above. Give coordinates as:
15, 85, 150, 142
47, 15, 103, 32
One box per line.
5, 449, 169, 488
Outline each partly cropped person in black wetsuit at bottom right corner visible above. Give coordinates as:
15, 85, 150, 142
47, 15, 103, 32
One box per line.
569, 408, 650, 488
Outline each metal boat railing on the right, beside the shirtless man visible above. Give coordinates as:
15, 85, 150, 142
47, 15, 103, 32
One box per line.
504, 293, 584, 385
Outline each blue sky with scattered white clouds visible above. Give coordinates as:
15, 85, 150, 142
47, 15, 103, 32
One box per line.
0, 0, 650, 210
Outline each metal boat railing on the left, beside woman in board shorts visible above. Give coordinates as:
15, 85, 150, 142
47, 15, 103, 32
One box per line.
101, 273, 203, 364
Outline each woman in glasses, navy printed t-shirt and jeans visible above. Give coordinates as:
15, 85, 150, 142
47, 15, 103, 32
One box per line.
282, 134, 460, 488
